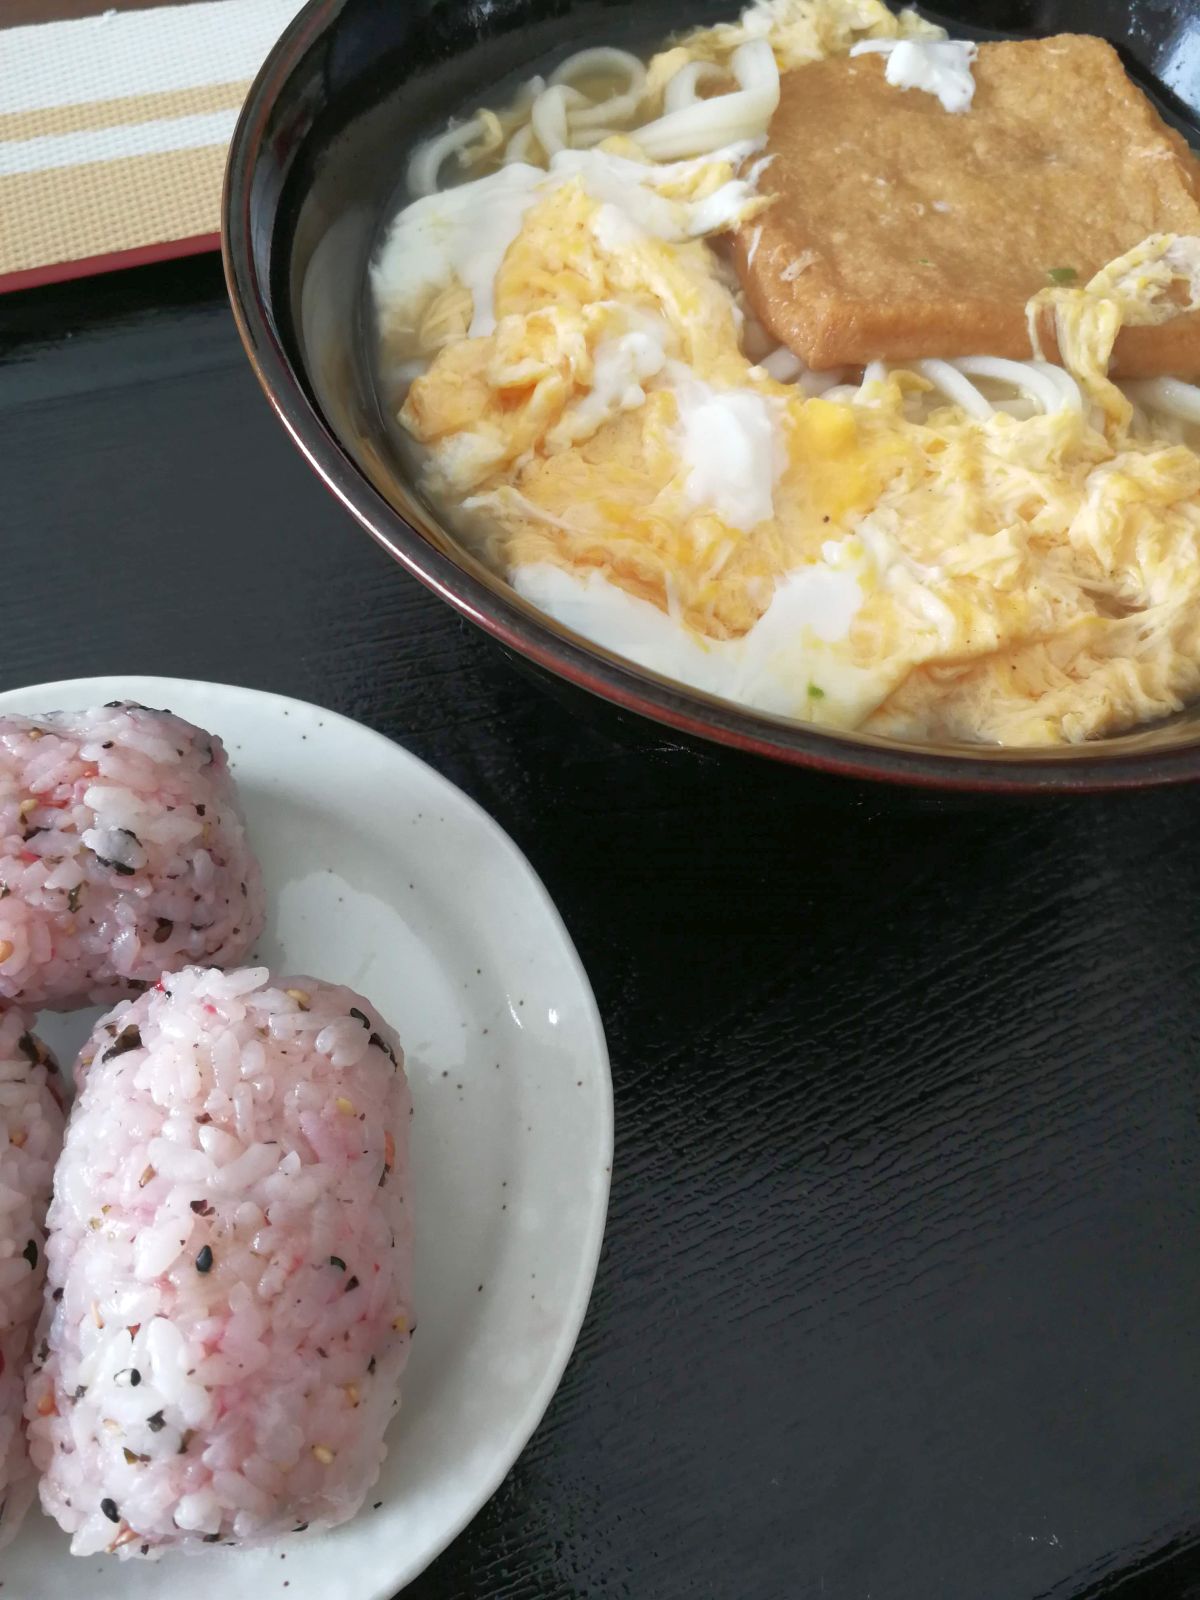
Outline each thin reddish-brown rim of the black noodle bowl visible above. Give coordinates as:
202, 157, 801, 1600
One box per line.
221, 0, 1200, 795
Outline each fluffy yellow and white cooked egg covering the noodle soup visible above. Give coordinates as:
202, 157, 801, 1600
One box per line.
376, 5, 1200, 746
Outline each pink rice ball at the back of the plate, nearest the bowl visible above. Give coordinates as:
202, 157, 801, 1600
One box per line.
0, 702, 262, 1010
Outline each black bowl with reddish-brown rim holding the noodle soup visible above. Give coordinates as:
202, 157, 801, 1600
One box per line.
224, 0, 1200, 794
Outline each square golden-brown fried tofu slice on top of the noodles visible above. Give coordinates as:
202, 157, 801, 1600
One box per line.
734, 34, 1200, 378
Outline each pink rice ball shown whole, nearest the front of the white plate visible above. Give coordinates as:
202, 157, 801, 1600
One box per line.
26, 968, 411, 1557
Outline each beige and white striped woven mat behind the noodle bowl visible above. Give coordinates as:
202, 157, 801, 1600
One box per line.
0, 0, 302, 291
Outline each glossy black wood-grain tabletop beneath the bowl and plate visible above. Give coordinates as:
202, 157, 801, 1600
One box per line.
0, 261, 1200, 1600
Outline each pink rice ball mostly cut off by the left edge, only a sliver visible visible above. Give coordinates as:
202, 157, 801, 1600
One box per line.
0, 1006, 62, 1550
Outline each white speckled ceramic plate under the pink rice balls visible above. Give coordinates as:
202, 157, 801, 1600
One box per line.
0, 677, 613, 1600
